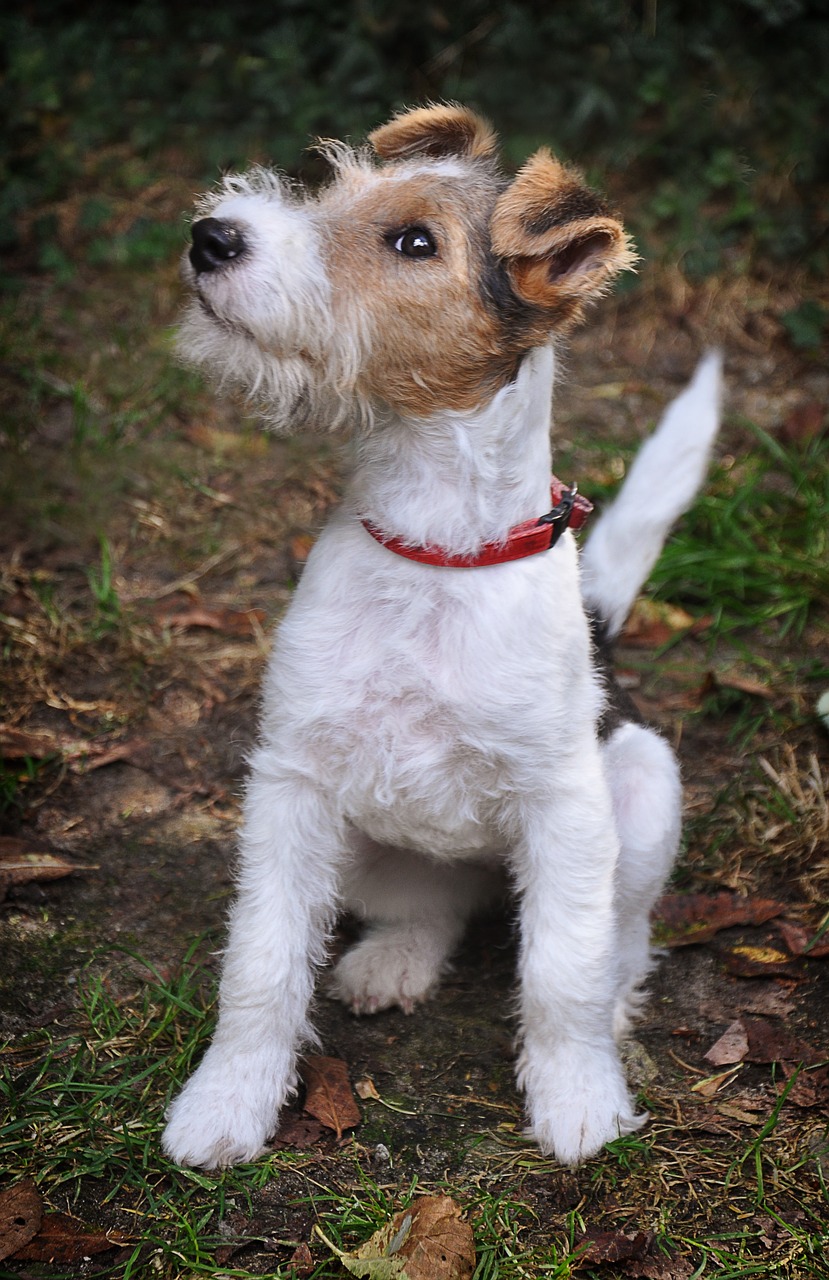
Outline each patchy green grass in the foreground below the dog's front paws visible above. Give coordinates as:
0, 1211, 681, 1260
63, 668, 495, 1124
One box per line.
0, 948, 829, 1280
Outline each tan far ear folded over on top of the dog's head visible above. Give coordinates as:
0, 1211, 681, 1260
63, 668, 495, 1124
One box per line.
368, 104, 498, 160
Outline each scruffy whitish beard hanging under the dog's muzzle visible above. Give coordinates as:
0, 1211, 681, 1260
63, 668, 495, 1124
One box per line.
177, 298, 365, 434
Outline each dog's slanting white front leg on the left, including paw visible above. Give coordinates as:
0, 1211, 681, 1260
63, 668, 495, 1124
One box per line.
162, 749, 345, 1169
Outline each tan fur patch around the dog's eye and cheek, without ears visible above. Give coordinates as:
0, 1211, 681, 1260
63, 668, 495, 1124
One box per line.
325, 168, 518, 415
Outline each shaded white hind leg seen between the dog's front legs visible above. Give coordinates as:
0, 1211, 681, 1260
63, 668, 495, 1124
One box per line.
331, 840, 503, 1014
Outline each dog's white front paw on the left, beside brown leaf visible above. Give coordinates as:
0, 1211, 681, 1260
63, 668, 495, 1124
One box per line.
161, 1052, 288, 1169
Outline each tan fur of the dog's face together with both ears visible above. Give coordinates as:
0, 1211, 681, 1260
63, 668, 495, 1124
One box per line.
320, 129, 631, 416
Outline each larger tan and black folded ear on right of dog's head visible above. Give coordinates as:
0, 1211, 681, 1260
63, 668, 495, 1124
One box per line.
491, 148, 637, 324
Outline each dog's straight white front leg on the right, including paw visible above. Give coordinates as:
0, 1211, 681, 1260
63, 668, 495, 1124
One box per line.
514, 744, 643, 1165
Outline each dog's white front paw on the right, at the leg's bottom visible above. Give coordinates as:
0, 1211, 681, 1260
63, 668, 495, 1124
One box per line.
522, 1047, 647, 1165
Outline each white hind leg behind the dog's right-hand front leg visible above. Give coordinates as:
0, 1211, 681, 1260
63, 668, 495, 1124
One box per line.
603, 723, 682, 1038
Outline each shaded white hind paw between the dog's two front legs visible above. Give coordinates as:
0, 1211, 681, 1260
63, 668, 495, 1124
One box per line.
330, 925, 444, 1014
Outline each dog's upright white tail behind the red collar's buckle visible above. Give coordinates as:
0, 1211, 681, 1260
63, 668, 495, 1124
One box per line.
581, 351, 723, 639
